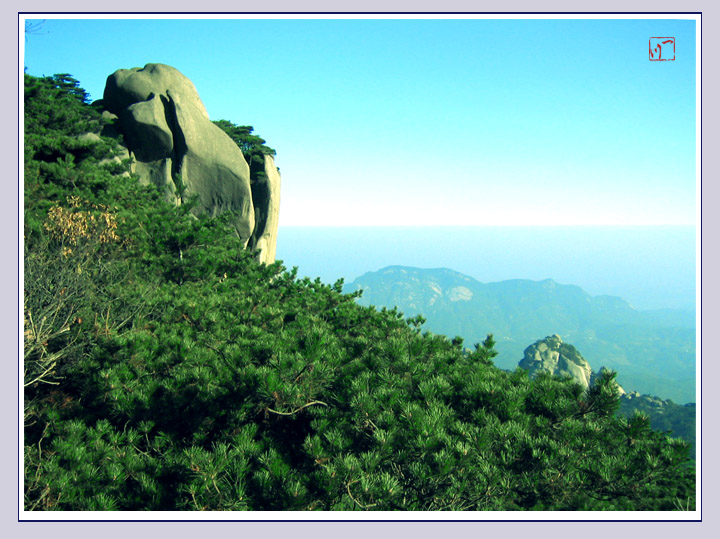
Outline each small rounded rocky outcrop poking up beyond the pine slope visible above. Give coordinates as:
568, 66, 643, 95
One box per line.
519, 335, 592, 389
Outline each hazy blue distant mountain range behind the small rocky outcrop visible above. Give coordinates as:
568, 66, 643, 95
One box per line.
345, 266, 695, 403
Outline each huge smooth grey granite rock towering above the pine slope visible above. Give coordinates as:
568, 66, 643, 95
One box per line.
103, 64, 280, 263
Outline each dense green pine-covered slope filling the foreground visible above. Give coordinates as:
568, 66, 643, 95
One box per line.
23, 75, 695, 511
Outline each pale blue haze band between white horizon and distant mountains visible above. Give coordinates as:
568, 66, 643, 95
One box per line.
277, 226, 695, 310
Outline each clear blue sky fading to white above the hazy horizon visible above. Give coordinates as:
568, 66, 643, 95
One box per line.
24, 15, 696, 226
